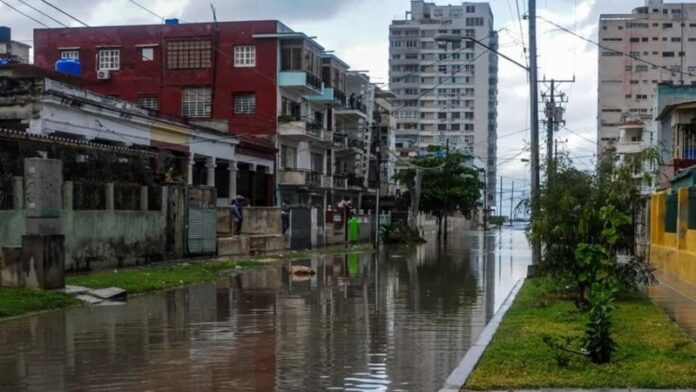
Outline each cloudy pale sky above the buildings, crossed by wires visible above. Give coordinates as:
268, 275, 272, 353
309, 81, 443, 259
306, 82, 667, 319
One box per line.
0, 0, 644, 208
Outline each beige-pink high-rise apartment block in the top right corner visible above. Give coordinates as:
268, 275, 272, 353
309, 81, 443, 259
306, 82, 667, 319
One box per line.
597, 0, 696, 154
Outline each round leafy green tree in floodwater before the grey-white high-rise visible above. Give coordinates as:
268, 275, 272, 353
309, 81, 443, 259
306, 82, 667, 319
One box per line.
395, 146, 483, 237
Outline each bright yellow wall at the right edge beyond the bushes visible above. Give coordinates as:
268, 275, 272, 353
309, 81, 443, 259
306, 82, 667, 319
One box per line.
649, 188, 696, 285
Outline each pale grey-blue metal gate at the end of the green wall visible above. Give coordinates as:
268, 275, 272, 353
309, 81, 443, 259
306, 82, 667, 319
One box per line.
186, 186, 217, 255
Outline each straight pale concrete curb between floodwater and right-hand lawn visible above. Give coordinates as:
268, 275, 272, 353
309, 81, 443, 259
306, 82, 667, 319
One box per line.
440, 279, 524, 392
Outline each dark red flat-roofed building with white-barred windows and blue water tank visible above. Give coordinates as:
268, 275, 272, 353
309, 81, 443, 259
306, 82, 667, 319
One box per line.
34, 21, 288, 205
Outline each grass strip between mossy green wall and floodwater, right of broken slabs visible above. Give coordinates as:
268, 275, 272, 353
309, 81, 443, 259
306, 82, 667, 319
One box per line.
66, 261, 261, 294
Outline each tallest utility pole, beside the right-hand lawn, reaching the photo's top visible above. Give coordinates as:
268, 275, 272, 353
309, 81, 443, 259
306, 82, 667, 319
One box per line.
528, 0, 541, 264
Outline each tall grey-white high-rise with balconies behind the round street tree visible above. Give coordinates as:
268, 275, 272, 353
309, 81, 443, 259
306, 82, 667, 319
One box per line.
389, 0, 498, 205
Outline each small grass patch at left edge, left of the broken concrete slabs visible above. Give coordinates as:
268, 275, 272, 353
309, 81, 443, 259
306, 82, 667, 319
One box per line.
0, 287, 81, 318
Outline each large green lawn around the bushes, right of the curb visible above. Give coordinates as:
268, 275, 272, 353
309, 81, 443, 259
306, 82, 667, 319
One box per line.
464, 279, 696, 390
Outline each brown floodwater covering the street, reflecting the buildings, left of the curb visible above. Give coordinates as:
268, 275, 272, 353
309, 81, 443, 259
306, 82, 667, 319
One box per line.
0, 229, 530, 392
